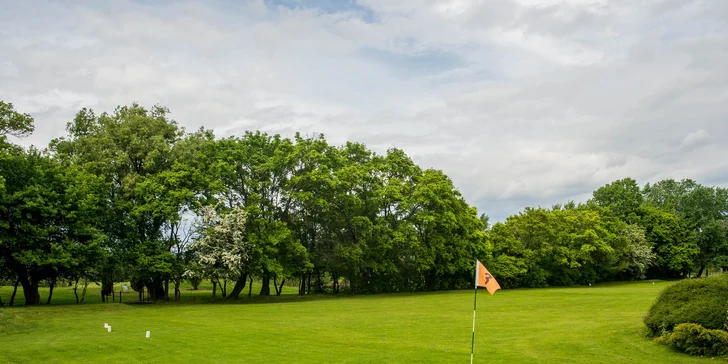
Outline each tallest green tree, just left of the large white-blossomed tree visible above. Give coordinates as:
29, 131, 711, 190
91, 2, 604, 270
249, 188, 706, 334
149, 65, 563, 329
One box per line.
51, 104, 195, 299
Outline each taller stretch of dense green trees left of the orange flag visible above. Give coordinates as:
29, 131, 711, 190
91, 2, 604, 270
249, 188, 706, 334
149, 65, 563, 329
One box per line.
0, 104, 485, 304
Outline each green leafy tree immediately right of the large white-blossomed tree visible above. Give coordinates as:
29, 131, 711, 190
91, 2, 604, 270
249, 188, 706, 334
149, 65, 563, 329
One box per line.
213, 132, 310, 296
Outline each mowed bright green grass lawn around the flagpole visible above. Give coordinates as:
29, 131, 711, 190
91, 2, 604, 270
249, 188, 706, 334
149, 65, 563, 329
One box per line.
0, 282, 718, 363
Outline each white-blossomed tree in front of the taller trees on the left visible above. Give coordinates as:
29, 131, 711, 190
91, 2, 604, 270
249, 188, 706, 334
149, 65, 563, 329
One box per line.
188, 206, 255, 299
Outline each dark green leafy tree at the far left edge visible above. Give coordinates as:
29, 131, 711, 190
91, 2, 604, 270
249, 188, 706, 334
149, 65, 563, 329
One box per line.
0, 147, 102, 305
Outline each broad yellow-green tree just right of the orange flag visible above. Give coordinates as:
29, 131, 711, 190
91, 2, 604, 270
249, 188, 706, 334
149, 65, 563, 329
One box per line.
488, 205, 653, 287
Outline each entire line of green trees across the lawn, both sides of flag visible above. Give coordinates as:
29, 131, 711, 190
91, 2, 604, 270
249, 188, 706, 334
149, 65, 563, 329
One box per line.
0, 101, 728, 304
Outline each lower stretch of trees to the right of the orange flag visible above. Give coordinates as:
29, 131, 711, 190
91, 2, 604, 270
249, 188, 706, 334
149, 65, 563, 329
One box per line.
487, 178, 728, 287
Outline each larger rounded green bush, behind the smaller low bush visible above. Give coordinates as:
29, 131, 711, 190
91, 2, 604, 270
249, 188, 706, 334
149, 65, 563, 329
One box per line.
644, 273, 728, 336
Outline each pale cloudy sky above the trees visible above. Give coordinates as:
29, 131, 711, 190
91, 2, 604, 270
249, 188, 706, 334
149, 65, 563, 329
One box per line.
0, 0, 728, 220
